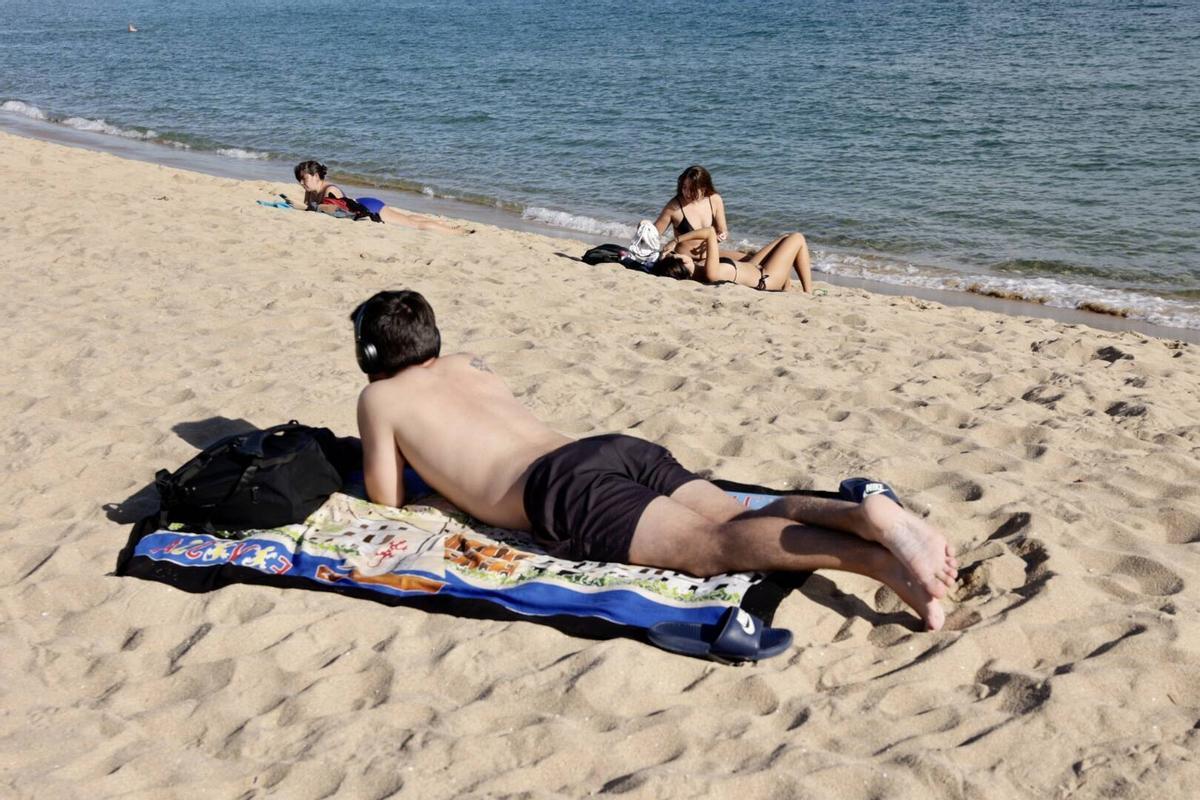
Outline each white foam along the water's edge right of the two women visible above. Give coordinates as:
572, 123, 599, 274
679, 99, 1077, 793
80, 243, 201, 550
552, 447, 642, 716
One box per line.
812, 253, 1200, 330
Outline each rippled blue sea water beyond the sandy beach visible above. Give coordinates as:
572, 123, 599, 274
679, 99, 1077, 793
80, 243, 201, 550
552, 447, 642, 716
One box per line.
0, 0, 1200, 329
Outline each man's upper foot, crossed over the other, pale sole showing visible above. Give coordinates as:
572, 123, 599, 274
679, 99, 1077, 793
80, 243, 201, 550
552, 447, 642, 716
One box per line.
859, 494, 959, 599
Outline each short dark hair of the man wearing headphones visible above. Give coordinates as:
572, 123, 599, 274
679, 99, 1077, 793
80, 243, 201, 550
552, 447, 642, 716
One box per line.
350, 289, 442, 377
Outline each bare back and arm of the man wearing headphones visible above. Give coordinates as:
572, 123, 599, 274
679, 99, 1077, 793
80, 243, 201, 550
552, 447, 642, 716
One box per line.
359, 354, 571, 530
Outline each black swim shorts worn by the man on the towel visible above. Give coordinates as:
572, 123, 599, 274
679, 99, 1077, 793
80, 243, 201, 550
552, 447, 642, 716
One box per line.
524, 433, 696, 563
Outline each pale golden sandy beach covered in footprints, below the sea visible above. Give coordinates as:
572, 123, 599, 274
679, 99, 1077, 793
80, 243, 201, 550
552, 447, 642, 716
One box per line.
0, 134, 1200, 800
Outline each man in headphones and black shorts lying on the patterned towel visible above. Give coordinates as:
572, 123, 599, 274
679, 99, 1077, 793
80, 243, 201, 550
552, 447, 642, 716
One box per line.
350, 290, 958, 631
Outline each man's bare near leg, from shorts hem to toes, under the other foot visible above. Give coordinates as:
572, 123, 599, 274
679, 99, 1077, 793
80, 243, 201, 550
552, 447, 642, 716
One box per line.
629, 487, 946, 631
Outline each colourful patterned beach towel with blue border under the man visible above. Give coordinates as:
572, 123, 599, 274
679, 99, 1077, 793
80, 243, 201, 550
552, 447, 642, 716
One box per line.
116, 485, 806, 652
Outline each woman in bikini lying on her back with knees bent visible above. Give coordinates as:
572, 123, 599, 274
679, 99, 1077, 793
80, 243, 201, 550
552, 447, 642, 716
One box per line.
654, 225, 812, 293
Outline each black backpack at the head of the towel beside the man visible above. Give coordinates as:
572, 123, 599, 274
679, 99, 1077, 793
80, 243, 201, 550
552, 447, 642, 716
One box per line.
155, 420, 355, 533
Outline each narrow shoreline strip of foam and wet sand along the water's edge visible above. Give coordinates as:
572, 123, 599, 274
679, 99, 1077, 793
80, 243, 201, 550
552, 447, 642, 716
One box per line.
0, 112, 1200, 344
